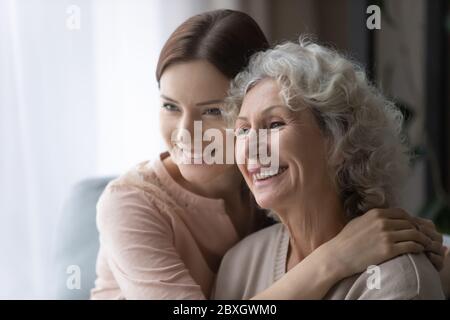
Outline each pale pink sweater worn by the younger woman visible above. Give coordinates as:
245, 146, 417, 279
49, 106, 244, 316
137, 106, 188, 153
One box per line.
91, 153, 264, 299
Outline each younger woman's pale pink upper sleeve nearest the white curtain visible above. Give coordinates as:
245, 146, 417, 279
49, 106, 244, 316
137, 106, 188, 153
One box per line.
97, 185, 205, 299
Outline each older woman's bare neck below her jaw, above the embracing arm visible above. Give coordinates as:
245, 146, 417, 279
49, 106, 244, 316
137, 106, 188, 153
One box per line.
276, 185, 347, 265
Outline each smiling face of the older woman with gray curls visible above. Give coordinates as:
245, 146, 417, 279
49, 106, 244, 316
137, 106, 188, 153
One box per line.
236, 79, 330, 210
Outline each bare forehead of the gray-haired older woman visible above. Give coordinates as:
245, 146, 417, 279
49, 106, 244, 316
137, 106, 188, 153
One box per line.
239, 78, 285, 116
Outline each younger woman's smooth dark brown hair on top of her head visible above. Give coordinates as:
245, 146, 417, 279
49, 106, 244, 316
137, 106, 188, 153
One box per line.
156, 10, 269, 83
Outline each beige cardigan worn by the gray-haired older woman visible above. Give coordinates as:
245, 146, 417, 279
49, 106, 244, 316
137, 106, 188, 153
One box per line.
213, 223, 444, 300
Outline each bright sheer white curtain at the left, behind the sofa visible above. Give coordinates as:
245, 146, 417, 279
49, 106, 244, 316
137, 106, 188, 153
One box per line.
0, 0, 97, 298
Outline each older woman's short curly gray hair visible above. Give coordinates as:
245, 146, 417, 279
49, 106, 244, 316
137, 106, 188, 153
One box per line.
227, 39, 409, 218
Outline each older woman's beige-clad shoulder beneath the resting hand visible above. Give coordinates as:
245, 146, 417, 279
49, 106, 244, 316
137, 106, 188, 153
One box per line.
342, 254, 444, 300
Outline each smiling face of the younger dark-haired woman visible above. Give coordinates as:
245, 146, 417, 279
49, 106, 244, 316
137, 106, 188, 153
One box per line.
160, 60, 234, 183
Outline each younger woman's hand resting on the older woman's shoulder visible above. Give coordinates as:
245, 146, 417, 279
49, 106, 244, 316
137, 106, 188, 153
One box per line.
320, 208, 445, 278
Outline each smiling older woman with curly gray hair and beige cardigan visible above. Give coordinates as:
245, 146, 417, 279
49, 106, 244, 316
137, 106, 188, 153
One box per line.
214, 41, 444, 299
